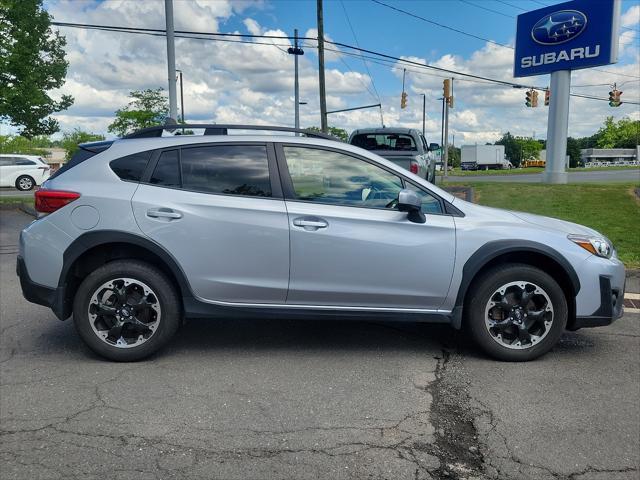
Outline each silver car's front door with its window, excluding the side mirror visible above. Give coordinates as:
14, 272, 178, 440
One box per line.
280, 145, 455, 310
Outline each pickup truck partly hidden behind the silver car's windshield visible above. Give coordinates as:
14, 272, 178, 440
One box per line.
349, 127, 440, 183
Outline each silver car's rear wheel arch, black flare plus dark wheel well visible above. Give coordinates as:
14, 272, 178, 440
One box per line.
58, 230, 193, 318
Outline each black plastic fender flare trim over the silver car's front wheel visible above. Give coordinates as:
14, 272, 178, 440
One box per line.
452, 240, 580, 328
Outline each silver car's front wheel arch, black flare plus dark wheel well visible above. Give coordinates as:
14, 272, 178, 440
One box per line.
452, 240, 580, 328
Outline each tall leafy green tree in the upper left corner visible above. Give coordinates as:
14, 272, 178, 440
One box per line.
0, 0, 73, 138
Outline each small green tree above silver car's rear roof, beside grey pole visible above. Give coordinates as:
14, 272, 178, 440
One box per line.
108, 88, 169, 137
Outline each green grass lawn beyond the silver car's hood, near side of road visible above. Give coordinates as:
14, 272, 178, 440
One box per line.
456, 182, 640, 268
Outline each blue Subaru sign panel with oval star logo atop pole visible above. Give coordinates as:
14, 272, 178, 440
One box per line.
514, 0, 620, 77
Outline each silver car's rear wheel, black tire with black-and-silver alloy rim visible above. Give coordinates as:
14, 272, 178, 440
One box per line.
73, 260, 181, 362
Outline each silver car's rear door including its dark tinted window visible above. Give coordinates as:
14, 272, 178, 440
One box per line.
132, 142, 289, 304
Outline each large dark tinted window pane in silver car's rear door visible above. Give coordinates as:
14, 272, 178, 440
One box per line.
180, 145, 272, 197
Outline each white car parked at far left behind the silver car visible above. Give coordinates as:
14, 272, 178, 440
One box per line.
0, 153, 51, 191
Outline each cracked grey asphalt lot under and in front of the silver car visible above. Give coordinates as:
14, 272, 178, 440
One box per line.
0, 210, 640, 480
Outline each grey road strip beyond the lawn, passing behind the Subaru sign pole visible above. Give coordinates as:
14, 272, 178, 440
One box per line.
444, 170, 640, 183
